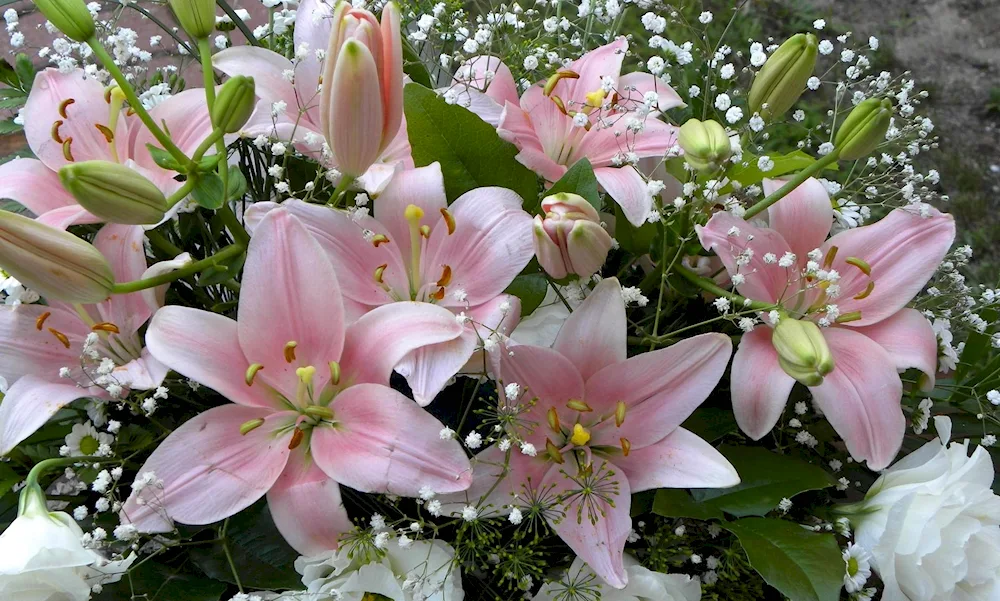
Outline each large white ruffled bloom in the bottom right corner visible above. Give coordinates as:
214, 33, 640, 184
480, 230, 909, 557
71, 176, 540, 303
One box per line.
852, 417, 1000, 601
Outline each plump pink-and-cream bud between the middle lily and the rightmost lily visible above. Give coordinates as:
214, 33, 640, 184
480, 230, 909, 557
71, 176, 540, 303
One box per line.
534, 193, 612, 280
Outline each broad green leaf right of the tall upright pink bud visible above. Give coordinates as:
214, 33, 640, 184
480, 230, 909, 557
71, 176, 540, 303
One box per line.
403, 84, 538, 208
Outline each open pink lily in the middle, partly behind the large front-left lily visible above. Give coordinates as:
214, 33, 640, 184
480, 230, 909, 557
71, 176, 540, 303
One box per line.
247, 163, 534, 406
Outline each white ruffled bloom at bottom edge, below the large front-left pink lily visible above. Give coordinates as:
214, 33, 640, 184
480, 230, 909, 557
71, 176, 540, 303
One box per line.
292, 540, 464, 601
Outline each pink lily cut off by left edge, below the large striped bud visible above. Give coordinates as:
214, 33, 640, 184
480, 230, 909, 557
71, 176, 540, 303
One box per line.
0, 224, 167, 455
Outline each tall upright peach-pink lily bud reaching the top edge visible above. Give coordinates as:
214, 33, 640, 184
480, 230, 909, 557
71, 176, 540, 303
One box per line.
320, 2, 403, 177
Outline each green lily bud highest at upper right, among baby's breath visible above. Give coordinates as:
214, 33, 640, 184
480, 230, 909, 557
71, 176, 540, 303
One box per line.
747, 33, 819, 119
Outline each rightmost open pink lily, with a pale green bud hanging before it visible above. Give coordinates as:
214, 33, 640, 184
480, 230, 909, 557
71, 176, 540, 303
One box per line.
698, 179, 955, 470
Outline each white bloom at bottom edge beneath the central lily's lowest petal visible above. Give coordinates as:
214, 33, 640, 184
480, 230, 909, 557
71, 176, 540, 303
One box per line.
532, 555, 701, 601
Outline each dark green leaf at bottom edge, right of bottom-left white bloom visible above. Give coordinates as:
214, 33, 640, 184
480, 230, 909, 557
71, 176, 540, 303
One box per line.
93, 561, 226, 601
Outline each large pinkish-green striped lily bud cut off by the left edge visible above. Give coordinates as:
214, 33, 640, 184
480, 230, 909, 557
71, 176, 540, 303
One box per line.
0, 211, 115, 303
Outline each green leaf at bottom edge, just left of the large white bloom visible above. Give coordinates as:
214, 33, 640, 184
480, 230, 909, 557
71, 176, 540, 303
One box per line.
722, 518, 844, 601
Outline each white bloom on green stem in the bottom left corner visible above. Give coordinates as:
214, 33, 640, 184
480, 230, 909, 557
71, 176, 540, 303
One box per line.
0, 486, 135, 601
